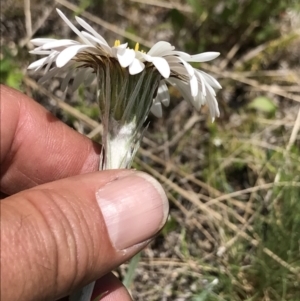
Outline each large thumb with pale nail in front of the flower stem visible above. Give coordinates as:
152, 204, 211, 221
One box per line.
1, 170, 168, 300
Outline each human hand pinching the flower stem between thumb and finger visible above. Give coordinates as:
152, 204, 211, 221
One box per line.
0, 86, 168, 301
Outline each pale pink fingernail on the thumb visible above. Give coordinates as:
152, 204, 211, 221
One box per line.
96, 172, 169, 250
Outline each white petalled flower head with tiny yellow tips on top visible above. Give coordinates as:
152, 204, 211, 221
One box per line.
28, 9, 221, 119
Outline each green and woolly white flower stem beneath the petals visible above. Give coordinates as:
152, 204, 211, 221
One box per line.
70, 58, 161, 301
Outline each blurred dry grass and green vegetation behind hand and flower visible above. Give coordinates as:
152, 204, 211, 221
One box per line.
0, 0, 300, 301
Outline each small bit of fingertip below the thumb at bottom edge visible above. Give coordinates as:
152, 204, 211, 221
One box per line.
92, 273, 132, 301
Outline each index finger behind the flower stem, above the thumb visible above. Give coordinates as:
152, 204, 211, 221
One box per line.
0, 85, 101, 195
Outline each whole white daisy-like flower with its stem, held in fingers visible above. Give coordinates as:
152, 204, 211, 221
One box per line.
28, 9, 221, 301
